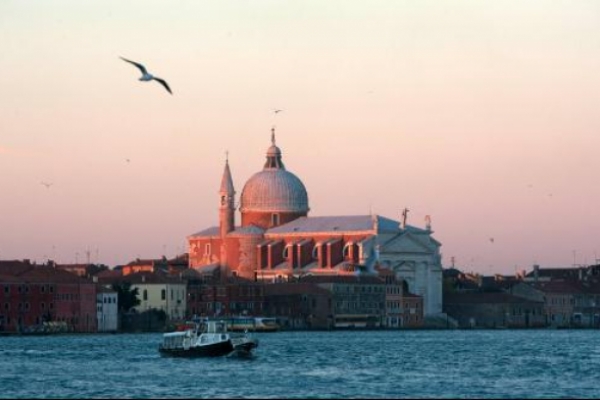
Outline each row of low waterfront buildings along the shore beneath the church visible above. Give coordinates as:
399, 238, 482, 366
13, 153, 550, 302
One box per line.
0, 255, 600, 334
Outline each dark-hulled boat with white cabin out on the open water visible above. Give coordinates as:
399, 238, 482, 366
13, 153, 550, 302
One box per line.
158, 320, 258, 357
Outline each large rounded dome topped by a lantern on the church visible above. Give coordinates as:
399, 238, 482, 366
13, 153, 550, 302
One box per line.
240, 132, 309, 213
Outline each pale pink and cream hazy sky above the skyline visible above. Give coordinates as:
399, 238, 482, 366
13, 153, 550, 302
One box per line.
0, 0, 600, 274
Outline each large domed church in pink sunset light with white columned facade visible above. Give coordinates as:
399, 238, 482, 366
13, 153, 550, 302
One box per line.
187, 129, 442, 316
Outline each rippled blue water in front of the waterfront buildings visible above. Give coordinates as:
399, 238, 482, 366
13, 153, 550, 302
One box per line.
0, 330, 600, 398
